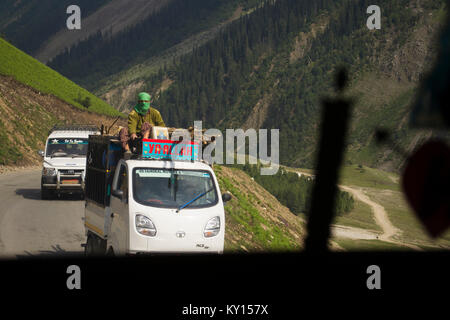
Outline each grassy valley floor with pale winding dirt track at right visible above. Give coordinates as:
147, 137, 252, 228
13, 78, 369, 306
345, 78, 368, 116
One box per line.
285, 165, 450, 250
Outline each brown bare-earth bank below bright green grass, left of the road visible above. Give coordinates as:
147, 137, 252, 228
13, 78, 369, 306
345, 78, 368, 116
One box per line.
0, 75, 126, 166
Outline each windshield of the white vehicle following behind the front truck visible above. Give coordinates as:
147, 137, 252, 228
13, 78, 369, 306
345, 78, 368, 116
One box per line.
46, 138, 88, 157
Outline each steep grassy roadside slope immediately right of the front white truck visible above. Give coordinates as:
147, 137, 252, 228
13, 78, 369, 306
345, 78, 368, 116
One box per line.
214, 166, 305, 252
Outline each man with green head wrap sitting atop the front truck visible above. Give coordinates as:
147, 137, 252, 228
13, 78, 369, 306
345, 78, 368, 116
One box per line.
119, 92, 166, 159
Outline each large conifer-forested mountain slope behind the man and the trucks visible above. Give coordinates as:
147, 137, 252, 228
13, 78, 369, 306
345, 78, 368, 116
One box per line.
4, 0, 446, 171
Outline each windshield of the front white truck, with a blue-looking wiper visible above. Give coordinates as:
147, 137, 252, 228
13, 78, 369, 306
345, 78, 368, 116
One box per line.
133, 168, 218, 209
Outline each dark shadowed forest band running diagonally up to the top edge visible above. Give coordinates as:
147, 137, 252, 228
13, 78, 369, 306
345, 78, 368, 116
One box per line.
48, 0, 254, 89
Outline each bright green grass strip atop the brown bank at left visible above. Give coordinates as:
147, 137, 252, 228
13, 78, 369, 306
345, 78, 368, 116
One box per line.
0, 38, 124, 116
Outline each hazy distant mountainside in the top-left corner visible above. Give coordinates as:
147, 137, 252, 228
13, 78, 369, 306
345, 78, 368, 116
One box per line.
0, 0, 172, 63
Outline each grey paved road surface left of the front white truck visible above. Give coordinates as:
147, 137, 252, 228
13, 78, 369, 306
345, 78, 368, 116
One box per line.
0, 169, 86, 258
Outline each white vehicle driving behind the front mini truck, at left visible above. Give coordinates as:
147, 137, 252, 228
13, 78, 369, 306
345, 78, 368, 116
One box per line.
39, 125, 100, 199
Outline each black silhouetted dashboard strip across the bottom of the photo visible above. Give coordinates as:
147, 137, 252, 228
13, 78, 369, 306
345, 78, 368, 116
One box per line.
0, 251, 450, 319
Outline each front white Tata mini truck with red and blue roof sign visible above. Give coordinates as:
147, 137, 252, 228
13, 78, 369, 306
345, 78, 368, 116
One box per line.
84, 136, 231, 255
